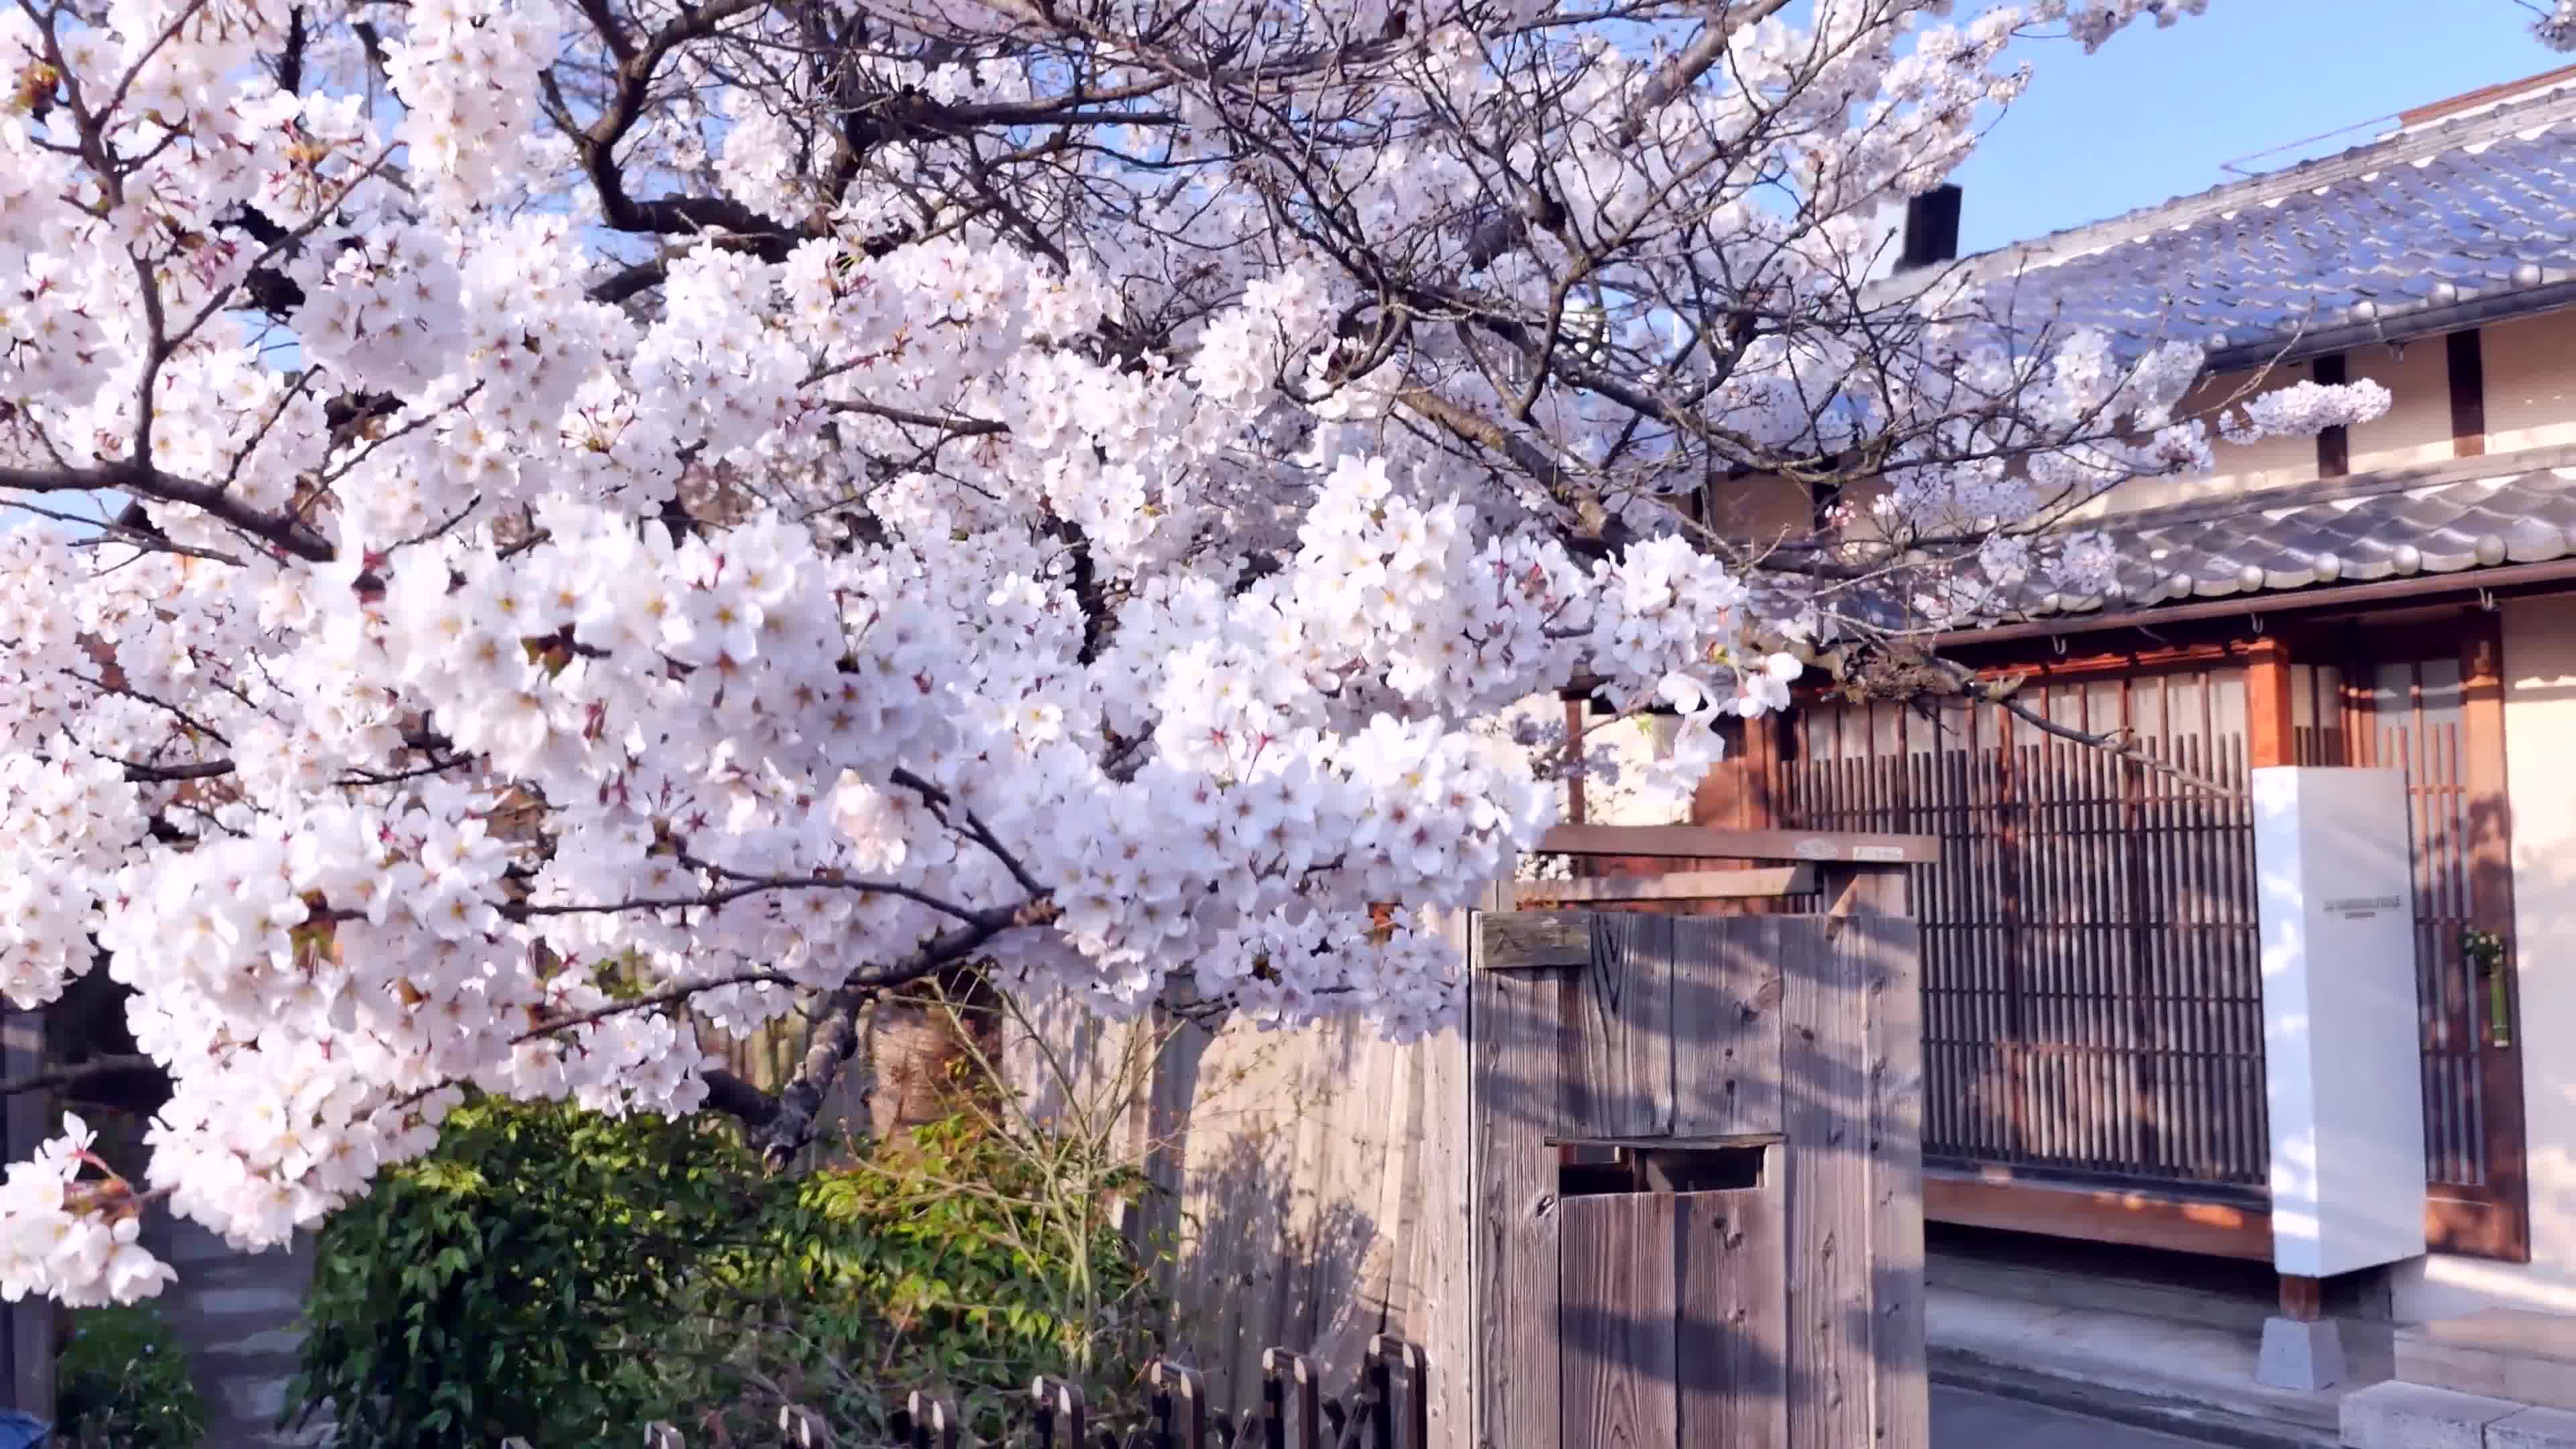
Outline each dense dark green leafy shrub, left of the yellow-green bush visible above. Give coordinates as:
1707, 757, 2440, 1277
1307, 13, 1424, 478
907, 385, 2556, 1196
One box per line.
294, 1098, 775, 1449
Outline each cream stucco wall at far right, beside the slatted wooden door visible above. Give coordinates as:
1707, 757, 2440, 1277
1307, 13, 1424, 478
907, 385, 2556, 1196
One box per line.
2393, 588, 2576, 1320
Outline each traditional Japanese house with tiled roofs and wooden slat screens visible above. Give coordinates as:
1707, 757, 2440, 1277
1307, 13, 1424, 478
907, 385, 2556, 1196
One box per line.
1638, 62, 2576, 1382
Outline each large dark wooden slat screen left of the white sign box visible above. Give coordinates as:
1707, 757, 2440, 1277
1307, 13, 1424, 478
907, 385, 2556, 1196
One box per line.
1780, 665, 2269, 1199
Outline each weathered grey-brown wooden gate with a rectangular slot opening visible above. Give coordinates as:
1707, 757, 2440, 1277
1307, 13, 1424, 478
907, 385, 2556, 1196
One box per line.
1466, 830, 1929, 1449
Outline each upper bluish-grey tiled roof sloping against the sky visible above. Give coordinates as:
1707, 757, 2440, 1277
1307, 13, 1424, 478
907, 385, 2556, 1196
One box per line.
1963, 85, 2576, 354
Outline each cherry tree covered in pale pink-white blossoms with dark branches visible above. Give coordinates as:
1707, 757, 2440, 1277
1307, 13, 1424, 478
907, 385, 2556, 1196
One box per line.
0, 0, 2463, 1302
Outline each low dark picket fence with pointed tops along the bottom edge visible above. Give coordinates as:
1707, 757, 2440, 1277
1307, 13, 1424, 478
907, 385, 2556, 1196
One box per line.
502, 1336, 1432, 1449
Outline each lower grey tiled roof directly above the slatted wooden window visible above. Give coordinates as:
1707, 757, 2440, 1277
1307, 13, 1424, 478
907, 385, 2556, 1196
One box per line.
1937, 451, 2576, 624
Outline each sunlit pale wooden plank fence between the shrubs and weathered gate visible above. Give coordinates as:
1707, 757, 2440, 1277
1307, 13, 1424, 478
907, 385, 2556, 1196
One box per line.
1005, 943, 1468, 1426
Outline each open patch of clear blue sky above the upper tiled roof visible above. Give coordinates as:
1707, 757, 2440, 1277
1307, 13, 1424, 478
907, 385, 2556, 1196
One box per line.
1953, 0, 2576, 250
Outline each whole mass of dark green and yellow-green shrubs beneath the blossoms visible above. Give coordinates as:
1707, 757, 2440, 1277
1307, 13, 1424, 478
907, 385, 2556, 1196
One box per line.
297, 1098, 1144, 1449
